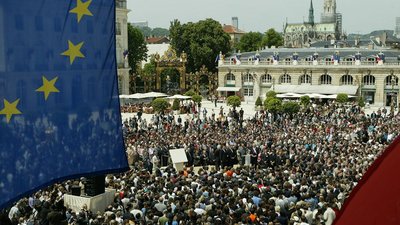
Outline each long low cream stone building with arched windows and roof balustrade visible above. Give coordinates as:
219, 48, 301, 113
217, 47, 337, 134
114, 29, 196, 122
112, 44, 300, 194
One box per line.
217, 48, 400, 106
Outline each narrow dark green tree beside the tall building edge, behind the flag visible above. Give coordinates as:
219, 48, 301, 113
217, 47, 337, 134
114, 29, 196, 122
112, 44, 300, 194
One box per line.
128, 24, 147, 74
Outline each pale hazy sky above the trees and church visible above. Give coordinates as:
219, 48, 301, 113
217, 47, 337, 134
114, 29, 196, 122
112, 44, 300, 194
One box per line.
127, 0, 400, 34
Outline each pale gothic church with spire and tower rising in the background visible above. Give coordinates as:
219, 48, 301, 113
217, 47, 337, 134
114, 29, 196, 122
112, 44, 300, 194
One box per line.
284, 0, 344, 48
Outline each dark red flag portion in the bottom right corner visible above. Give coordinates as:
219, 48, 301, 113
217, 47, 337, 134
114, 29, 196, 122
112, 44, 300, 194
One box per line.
335, 137, 400, 225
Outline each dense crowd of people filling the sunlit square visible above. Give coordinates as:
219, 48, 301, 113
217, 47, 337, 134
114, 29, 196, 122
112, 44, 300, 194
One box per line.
0, 103, 400, 225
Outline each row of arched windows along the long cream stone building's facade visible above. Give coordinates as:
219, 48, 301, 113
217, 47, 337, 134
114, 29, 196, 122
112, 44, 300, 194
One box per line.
226, 73, 399, 86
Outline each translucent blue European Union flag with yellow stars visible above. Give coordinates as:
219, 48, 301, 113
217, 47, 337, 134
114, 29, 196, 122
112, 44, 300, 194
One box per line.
0, 0, 128, 208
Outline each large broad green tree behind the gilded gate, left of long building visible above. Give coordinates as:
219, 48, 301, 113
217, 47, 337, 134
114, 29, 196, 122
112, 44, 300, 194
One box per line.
169, 19, 231, 72
